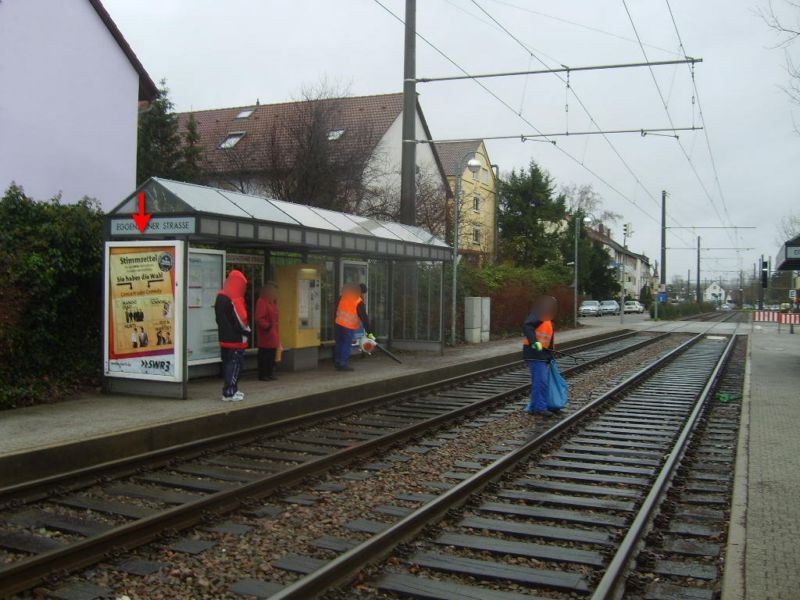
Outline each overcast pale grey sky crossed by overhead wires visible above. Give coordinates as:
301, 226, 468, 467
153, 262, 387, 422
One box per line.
104, 0, 800, 278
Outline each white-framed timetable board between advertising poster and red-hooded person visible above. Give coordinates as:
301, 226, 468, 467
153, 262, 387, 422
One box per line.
186, 248, 225, 365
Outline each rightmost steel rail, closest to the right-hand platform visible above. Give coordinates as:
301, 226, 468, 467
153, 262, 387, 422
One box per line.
592, 335, 737, 600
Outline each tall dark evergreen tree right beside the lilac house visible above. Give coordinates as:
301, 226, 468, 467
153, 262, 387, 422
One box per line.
136, 79, 184, 185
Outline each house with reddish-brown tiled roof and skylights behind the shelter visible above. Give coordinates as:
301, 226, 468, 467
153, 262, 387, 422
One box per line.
178, 94, 447, 235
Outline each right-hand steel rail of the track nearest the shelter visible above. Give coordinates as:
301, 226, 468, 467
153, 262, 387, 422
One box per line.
0, 332, 664, 597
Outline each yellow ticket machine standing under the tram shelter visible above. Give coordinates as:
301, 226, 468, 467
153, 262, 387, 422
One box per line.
275, 265, 322, 371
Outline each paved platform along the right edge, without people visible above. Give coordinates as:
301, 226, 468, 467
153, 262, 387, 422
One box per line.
722, 323, 800, 600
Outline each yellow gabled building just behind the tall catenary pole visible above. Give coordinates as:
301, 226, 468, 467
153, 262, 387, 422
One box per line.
436, 140, 497, 264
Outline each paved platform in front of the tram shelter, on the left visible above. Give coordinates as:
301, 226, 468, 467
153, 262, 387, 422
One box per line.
0, 322, 620, 486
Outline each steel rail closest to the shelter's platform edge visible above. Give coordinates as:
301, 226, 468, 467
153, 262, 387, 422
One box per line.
0, 331, 643, 508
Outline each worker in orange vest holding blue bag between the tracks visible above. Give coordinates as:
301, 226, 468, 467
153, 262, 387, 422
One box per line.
522, 296, 558, 416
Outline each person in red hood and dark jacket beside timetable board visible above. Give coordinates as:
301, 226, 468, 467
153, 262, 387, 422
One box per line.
214, 269, 250, 402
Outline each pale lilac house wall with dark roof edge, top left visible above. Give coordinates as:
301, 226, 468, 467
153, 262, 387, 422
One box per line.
0, 0, 158, 207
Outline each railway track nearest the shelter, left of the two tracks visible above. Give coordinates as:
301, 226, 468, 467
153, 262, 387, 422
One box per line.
0, 333, 666, 596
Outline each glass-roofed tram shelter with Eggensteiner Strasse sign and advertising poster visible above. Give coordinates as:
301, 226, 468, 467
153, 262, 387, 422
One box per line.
103, 178, 452, 398
